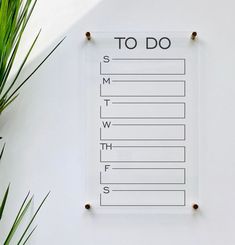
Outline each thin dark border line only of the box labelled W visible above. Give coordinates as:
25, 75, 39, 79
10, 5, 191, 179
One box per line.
100, 124, 186, 141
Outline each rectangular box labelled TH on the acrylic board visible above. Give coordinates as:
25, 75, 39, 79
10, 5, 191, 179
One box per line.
100, 145, 186, 163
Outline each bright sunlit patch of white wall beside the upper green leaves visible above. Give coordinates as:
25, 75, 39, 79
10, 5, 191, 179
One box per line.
15, 0, 100, 66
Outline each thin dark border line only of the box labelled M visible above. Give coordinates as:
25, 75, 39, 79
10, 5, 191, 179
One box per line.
100, 80, 186, 98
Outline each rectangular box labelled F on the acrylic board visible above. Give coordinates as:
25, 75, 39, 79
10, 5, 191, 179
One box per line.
100, 166, 186, 185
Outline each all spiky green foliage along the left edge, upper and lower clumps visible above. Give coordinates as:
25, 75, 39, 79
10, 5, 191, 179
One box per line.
0, 0, 63, 245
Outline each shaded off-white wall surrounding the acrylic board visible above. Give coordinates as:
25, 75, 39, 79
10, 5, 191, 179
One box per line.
0, 0, 235, 245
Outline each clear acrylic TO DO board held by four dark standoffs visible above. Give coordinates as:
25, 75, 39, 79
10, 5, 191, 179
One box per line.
82, 32, 199, 213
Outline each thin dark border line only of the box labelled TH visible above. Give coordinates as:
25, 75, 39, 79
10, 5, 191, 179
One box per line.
100, 146, 186, 163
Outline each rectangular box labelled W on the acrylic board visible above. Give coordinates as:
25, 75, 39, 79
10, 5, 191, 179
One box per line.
100, 123, 186, 141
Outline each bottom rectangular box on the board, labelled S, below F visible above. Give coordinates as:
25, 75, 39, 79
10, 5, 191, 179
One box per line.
100, 188, 186, 206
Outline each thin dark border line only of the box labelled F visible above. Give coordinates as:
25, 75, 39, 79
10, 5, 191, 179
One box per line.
100, 168, 186, 185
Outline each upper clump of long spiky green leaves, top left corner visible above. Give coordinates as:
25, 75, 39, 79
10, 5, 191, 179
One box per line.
0, 0, 64, 113
